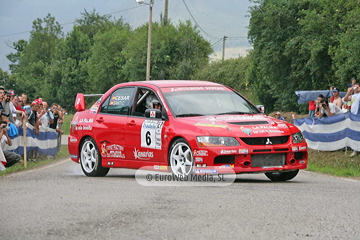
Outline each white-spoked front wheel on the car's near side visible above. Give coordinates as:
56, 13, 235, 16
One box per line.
169, 138, 194, 176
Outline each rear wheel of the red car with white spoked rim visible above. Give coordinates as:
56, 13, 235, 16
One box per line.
80, 137, 110, 177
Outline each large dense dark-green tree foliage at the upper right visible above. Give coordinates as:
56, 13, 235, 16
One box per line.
249, 0, 360, 111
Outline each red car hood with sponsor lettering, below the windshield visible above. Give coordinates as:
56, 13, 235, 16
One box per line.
176, 114, 294, 137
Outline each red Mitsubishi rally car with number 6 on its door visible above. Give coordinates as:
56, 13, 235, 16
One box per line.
68, 80, 308, 181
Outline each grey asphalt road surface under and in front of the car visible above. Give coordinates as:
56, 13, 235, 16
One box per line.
0, 160, 360, 240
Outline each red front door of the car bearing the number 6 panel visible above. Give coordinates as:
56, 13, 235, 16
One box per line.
126, 88, 164, 165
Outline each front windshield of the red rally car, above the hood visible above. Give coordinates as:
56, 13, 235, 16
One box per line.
164, 90, 260, 117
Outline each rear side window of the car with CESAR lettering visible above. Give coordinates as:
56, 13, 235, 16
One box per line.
100, 87, 135, 115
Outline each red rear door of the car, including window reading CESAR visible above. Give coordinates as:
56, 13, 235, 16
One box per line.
93, 87, 135, 161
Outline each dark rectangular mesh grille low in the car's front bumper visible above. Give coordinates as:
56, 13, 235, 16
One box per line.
251, 153, 285, 167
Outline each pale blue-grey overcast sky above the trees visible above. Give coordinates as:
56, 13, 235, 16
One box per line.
0, 0, 250, 71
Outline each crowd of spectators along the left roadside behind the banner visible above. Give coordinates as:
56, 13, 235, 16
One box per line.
0, 86, 64, 171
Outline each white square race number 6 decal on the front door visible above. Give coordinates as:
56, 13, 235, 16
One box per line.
141, 119, 164, 149
